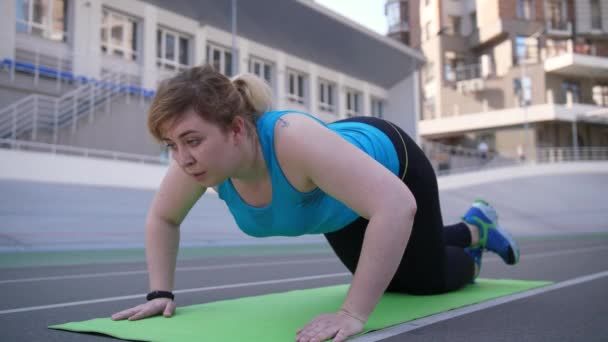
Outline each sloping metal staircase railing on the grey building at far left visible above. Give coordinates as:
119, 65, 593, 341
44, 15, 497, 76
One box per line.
0, 73, 134, 143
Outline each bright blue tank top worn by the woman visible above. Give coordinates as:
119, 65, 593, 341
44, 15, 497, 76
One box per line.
218, 111, 399, 237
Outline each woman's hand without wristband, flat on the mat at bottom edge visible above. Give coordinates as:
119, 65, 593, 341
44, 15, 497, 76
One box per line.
296, 311, 364, 342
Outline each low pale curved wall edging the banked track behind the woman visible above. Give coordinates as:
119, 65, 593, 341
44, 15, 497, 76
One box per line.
0, 149, 608, 195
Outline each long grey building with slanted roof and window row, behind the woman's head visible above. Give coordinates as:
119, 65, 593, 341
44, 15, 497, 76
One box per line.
0, 0, 424, 156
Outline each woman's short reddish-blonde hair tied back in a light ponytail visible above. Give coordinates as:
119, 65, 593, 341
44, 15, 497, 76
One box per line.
148, 65, 272, 141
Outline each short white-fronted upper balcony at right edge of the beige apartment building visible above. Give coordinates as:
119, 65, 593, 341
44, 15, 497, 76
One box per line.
543, 39, 608, 79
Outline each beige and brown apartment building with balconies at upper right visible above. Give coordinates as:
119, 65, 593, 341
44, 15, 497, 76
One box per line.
385, 0, 608, 159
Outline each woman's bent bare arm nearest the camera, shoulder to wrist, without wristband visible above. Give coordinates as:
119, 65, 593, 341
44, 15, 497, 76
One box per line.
275, 115, 416, 321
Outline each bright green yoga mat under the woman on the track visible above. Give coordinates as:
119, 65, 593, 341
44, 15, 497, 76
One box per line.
49, 279, 551, 342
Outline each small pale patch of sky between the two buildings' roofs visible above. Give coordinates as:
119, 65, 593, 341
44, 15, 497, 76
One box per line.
314, 0, 388, 35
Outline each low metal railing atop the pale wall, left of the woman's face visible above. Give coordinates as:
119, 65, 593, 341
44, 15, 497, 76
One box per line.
0, 139, 168, 165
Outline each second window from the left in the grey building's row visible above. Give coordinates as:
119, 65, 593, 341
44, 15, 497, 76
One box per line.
101, 9, 137, 61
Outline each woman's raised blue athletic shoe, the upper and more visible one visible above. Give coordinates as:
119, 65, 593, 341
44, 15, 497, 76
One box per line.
462, 200, 519, 265
